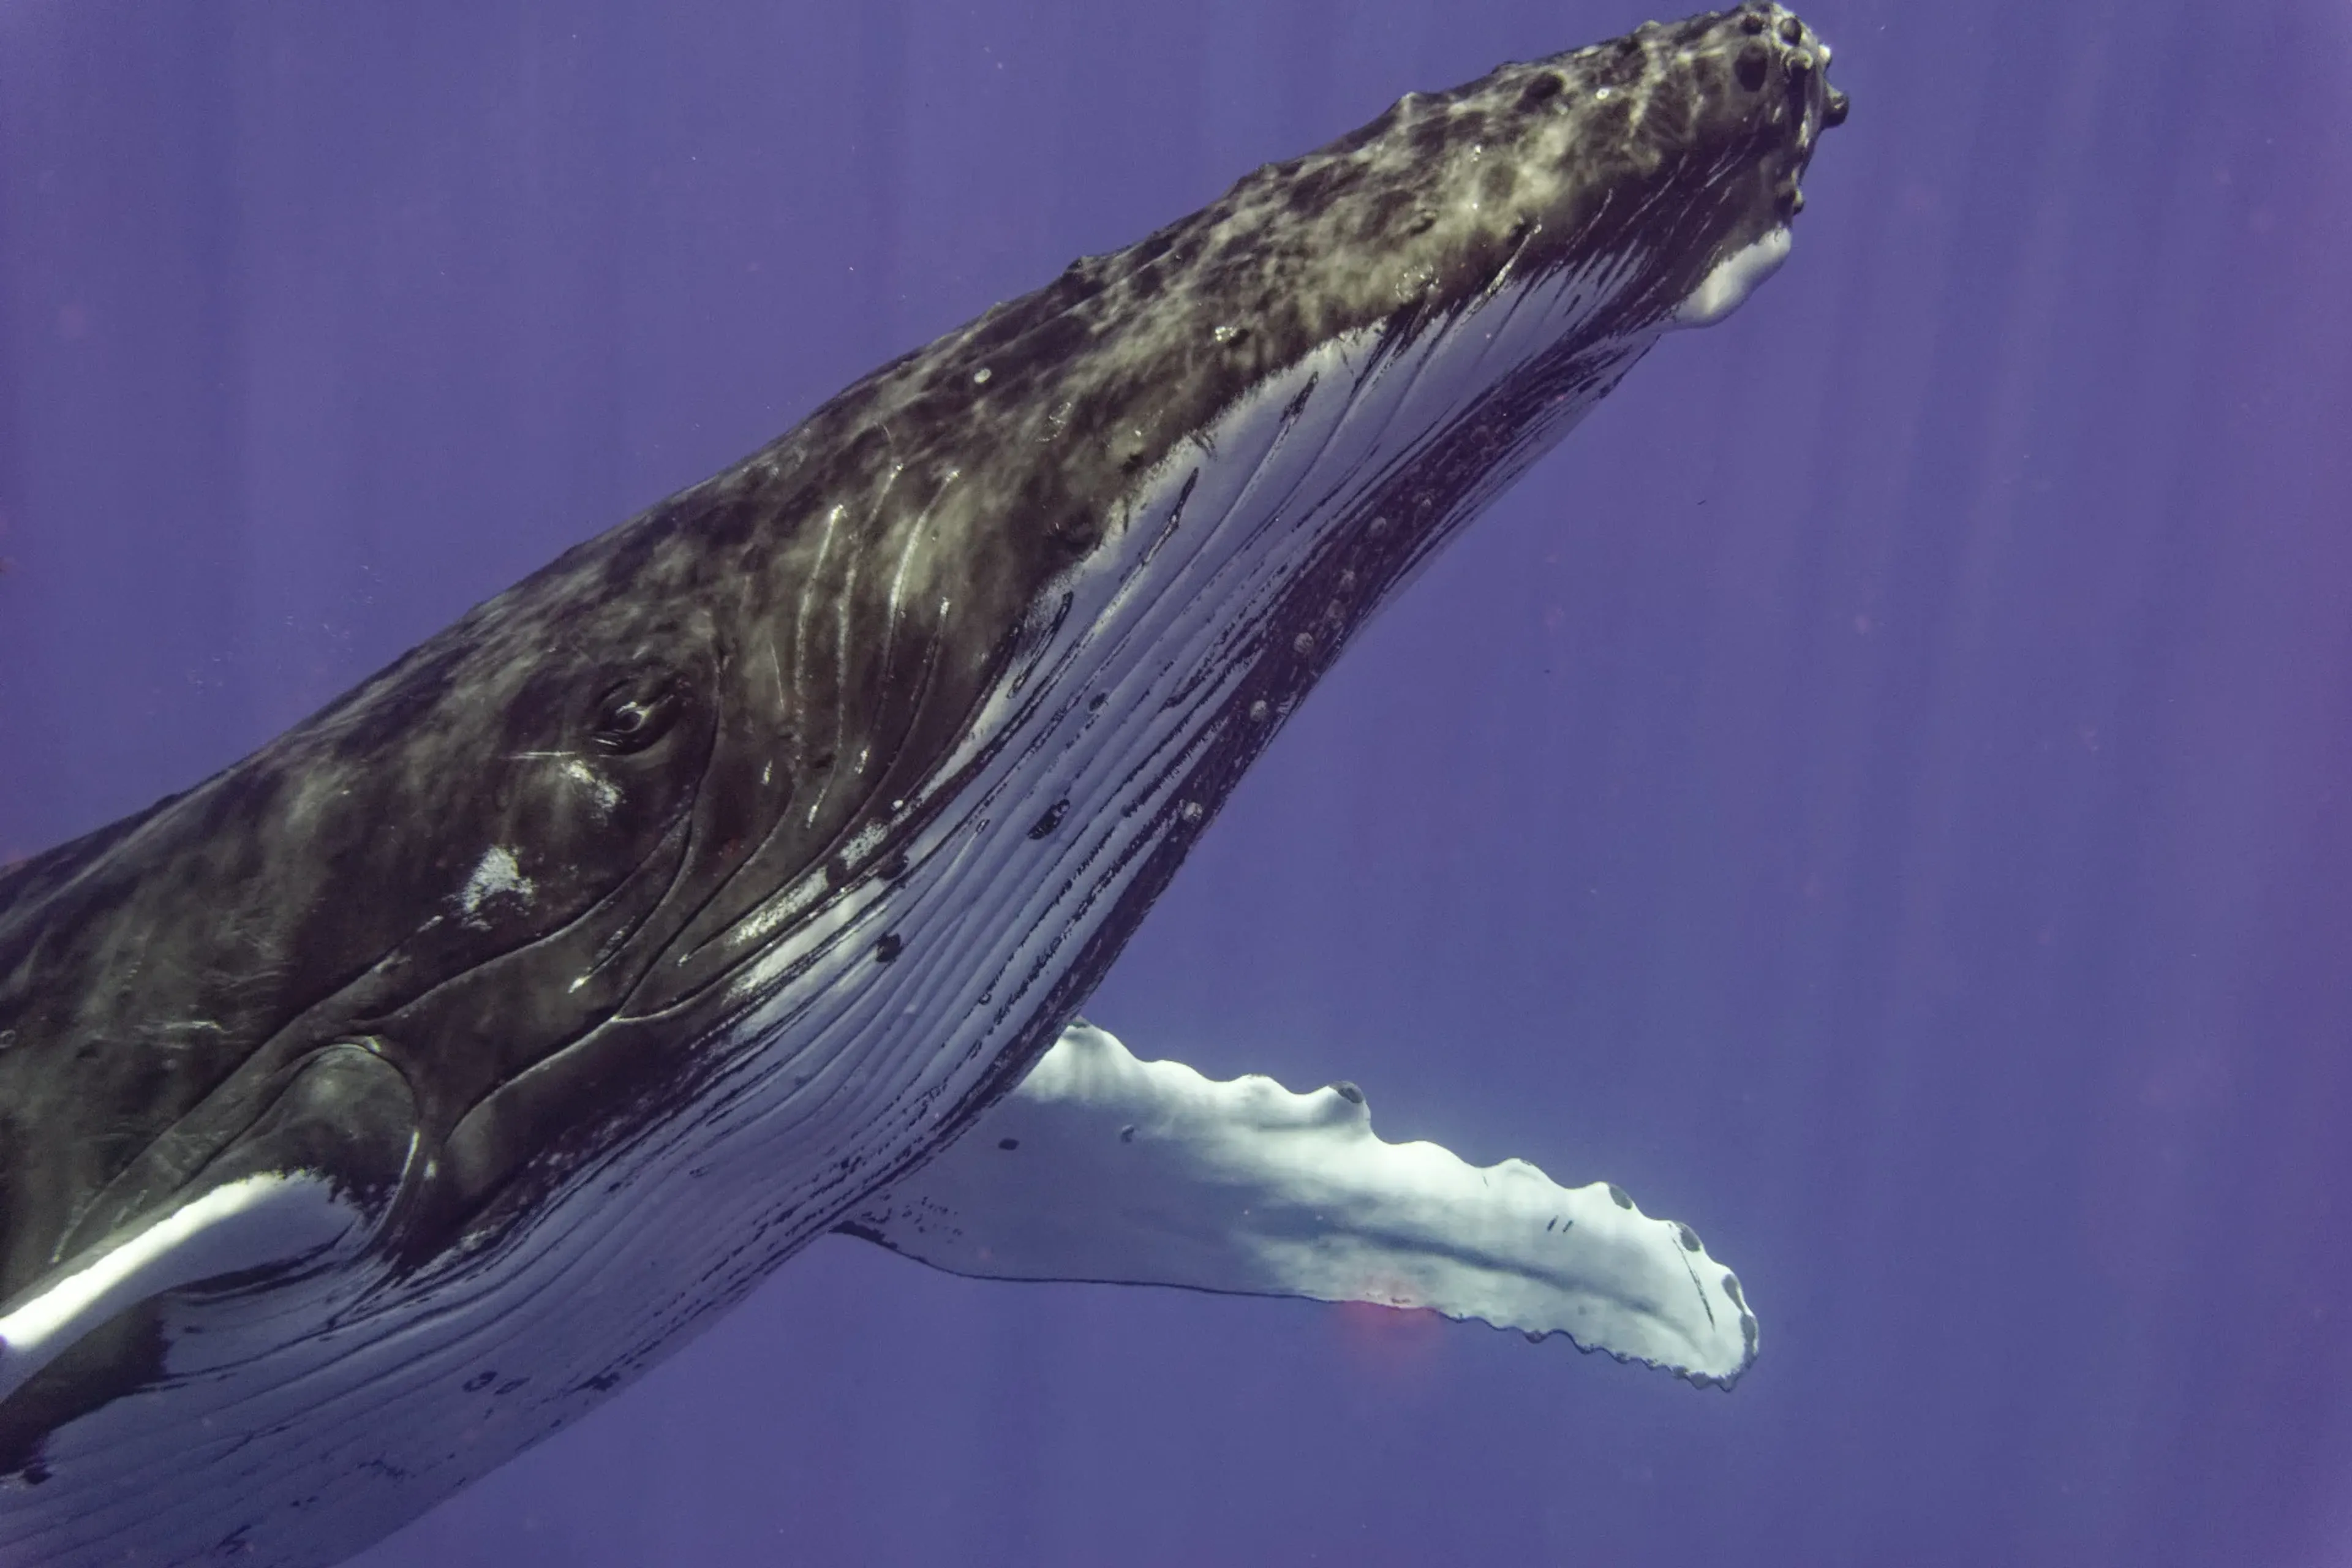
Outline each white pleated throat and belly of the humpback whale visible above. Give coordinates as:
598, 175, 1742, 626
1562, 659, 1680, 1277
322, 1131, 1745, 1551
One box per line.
0, 258, 1670, 1568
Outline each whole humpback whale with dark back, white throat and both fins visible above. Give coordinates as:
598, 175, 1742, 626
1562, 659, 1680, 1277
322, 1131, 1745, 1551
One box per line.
0, 2, 1846, 1568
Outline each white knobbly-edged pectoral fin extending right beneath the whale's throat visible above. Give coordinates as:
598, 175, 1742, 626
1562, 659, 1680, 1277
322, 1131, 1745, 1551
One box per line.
842, 1023, 1757, 1387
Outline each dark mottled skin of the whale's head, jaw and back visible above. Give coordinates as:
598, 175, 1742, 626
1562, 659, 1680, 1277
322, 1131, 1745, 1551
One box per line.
0, 9, 1844, 1542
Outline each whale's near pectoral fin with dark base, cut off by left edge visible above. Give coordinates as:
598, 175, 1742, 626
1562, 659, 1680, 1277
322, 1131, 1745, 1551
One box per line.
0, 1041, 417, 1420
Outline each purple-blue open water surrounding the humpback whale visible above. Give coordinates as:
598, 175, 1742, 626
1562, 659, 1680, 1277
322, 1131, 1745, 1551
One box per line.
0, 0, 2352, 1568
